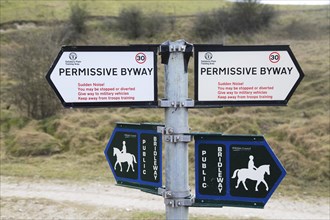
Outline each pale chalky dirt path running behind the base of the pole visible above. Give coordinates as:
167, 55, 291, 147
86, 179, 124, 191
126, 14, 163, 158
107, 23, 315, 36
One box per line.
0, 177, 330, 219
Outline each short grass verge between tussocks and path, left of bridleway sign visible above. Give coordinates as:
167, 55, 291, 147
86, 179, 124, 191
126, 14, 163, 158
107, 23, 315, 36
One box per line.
1, 153, 114, 182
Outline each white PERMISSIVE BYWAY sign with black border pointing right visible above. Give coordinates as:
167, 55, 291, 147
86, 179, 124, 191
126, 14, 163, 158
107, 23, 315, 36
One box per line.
194, 45, 304, 106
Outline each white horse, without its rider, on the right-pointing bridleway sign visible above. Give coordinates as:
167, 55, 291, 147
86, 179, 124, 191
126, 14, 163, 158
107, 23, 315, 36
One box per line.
231, 164, 270, 191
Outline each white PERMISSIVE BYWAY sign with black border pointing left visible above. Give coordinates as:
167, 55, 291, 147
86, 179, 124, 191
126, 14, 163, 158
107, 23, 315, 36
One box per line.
46, 46, 157, 107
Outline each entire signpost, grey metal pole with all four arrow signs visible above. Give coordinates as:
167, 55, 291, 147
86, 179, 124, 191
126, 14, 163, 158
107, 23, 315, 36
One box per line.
46, 40, 304, 219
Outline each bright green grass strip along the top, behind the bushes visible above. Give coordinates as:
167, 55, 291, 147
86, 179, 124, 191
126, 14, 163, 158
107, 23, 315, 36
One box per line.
0, 0, 226, 23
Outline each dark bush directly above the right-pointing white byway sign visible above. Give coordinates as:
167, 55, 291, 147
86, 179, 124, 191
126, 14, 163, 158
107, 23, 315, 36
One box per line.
193, 0, 275, 39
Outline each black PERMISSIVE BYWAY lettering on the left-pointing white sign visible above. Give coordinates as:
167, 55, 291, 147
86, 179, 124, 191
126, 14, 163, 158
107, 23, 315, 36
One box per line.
58, 68, 154, 76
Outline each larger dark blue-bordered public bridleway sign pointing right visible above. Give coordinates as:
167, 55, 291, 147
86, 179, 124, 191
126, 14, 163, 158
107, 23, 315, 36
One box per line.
194, 134, 286, 208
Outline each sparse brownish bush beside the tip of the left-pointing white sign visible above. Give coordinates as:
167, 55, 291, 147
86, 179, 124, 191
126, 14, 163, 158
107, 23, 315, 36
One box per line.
4, 31, 62, 119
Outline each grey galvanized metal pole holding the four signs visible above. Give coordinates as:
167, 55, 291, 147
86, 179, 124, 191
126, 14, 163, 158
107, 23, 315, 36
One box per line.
160, 40, 192, 219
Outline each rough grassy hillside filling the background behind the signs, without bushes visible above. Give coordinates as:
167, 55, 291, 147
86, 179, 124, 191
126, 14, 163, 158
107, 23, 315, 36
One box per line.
0, 1, 330, 203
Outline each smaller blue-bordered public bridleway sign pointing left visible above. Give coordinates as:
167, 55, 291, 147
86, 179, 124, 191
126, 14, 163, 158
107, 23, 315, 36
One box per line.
104, 123, 162, 193
